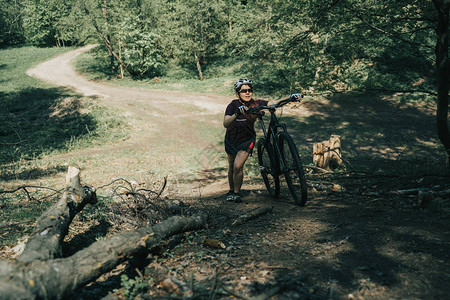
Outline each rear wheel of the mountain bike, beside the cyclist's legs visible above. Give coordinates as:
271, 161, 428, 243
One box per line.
258, 138, 280, 198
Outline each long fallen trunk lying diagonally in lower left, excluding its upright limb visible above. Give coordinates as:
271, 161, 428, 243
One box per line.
0, 217, 204, 299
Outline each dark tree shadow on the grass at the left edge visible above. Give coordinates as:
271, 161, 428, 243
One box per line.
0, 88, 97, 180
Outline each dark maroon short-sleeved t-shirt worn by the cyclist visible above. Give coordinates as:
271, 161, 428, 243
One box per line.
225, 99, 269, 145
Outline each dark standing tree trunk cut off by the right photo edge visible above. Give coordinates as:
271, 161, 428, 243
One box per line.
433, 0, 450, 166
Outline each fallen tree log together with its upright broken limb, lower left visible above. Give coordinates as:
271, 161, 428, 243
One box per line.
0, 168, 205, 299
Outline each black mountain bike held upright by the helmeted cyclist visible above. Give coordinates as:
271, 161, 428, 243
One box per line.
247, 94, 308, 206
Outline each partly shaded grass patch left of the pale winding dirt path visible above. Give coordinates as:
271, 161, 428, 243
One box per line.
0, 47, 127, 170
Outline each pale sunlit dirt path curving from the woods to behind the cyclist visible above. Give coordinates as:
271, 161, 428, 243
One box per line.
27, 45, 229, 135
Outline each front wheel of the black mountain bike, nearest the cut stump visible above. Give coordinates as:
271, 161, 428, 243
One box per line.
278, 132, 308, 206
